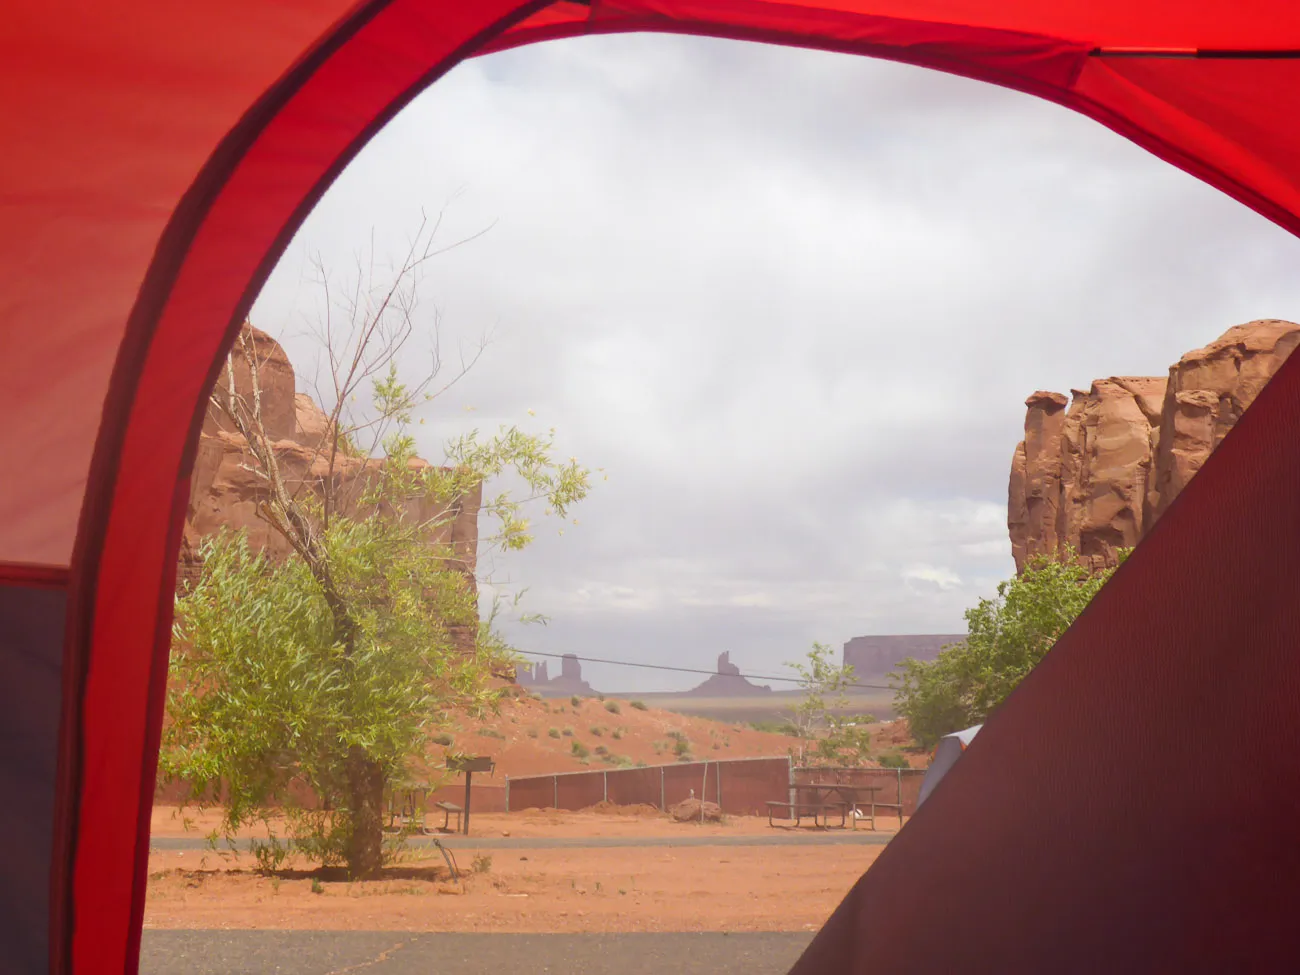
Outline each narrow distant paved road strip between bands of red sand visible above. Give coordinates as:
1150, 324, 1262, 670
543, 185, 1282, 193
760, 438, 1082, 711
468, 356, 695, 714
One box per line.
150, 829, 894, 850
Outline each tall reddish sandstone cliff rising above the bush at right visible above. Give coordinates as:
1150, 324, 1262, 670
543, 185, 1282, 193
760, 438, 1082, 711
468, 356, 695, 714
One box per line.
1006, 320, 1300, 572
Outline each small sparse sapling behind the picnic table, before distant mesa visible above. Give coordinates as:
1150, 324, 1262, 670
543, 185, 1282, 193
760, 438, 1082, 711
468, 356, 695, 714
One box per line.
787, 644, 875, 764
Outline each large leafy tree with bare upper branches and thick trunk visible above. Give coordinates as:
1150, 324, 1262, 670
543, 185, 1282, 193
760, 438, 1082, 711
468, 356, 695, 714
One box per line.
160, 215, 589, 878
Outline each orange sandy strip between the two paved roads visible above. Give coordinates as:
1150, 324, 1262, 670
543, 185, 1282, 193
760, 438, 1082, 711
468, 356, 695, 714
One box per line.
144, 845, 883, 932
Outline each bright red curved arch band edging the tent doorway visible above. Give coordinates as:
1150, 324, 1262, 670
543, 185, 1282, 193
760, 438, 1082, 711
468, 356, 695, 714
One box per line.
12, 0, 1300, 971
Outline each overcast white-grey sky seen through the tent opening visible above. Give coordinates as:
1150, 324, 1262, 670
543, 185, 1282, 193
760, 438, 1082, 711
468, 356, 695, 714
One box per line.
254, 35, 1300, 690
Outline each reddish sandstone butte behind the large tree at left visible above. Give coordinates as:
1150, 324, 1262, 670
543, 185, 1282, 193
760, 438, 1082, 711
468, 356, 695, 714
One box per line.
172, 329, 480, 646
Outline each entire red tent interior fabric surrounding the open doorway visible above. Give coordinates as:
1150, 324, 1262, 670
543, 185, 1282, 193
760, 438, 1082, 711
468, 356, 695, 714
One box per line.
0, 0, 1300, 972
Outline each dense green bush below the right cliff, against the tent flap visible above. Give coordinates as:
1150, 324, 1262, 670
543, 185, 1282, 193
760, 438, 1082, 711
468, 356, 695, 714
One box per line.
892, 549, 1128, 748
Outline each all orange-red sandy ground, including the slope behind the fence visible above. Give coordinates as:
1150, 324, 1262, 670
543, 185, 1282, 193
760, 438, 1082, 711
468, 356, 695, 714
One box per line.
144, 697, 926, 932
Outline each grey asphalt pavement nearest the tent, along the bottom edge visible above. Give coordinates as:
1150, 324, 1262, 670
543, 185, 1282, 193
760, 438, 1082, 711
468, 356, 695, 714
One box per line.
140, 931, 813, 975
